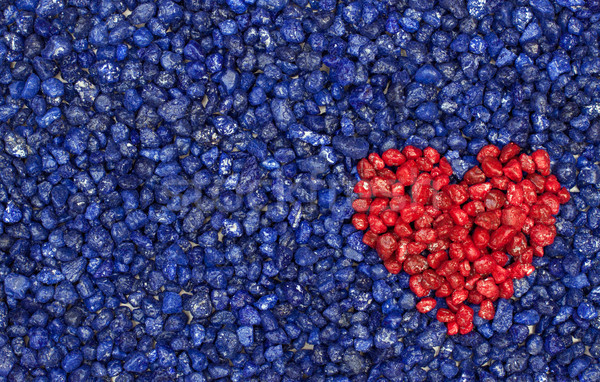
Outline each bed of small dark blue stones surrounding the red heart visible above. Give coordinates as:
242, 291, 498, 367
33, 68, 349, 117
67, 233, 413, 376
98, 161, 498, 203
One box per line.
0, 0, 600, 382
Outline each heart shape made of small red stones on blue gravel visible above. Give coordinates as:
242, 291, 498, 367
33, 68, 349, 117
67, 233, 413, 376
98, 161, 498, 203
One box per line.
352, 143, 570, 335
